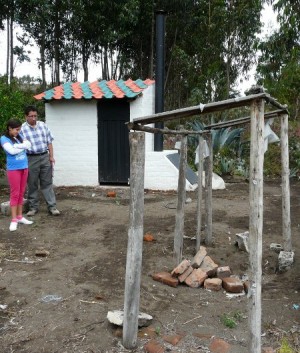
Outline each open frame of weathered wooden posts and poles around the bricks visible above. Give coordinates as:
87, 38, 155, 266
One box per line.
123, 93, 292, 353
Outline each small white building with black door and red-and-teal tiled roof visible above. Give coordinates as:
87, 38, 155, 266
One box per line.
35, 80, 197, 190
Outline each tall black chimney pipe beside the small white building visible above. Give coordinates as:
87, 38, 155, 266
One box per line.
154, 10, 166, 152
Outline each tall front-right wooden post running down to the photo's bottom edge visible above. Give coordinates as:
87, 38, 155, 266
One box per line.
248, 99, 264, 353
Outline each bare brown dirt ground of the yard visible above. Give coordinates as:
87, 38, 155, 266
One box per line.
0, 181, 300, 353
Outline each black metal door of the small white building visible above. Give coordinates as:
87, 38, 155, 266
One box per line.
97, 99, 130, 184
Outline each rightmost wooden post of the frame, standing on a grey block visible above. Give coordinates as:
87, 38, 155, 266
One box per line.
280, 114, 292, 251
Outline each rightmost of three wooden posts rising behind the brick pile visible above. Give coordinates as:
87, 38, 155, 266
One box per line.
204, 134, 213, 245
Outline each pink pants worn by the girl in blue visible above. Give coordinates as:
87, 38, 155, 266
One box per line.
7, 168, 28, 206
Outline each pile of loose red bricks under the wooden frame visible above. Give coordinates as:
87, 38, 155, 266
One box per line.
152, 246, 248, 293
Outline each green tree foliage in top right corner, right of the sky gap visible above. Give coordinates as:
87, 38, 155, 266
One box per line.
257, 0, 300, 119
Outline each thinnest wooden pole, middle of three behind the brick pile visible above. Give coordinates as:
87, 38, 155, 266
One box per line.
196, 135, 204, 253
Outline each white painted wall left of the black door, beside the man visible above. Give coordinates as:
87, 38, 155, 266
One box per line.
46, 99, 98, 186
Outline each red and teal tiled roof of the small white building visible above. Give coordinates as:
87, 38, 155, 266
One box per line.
34, 79, 154, 100
